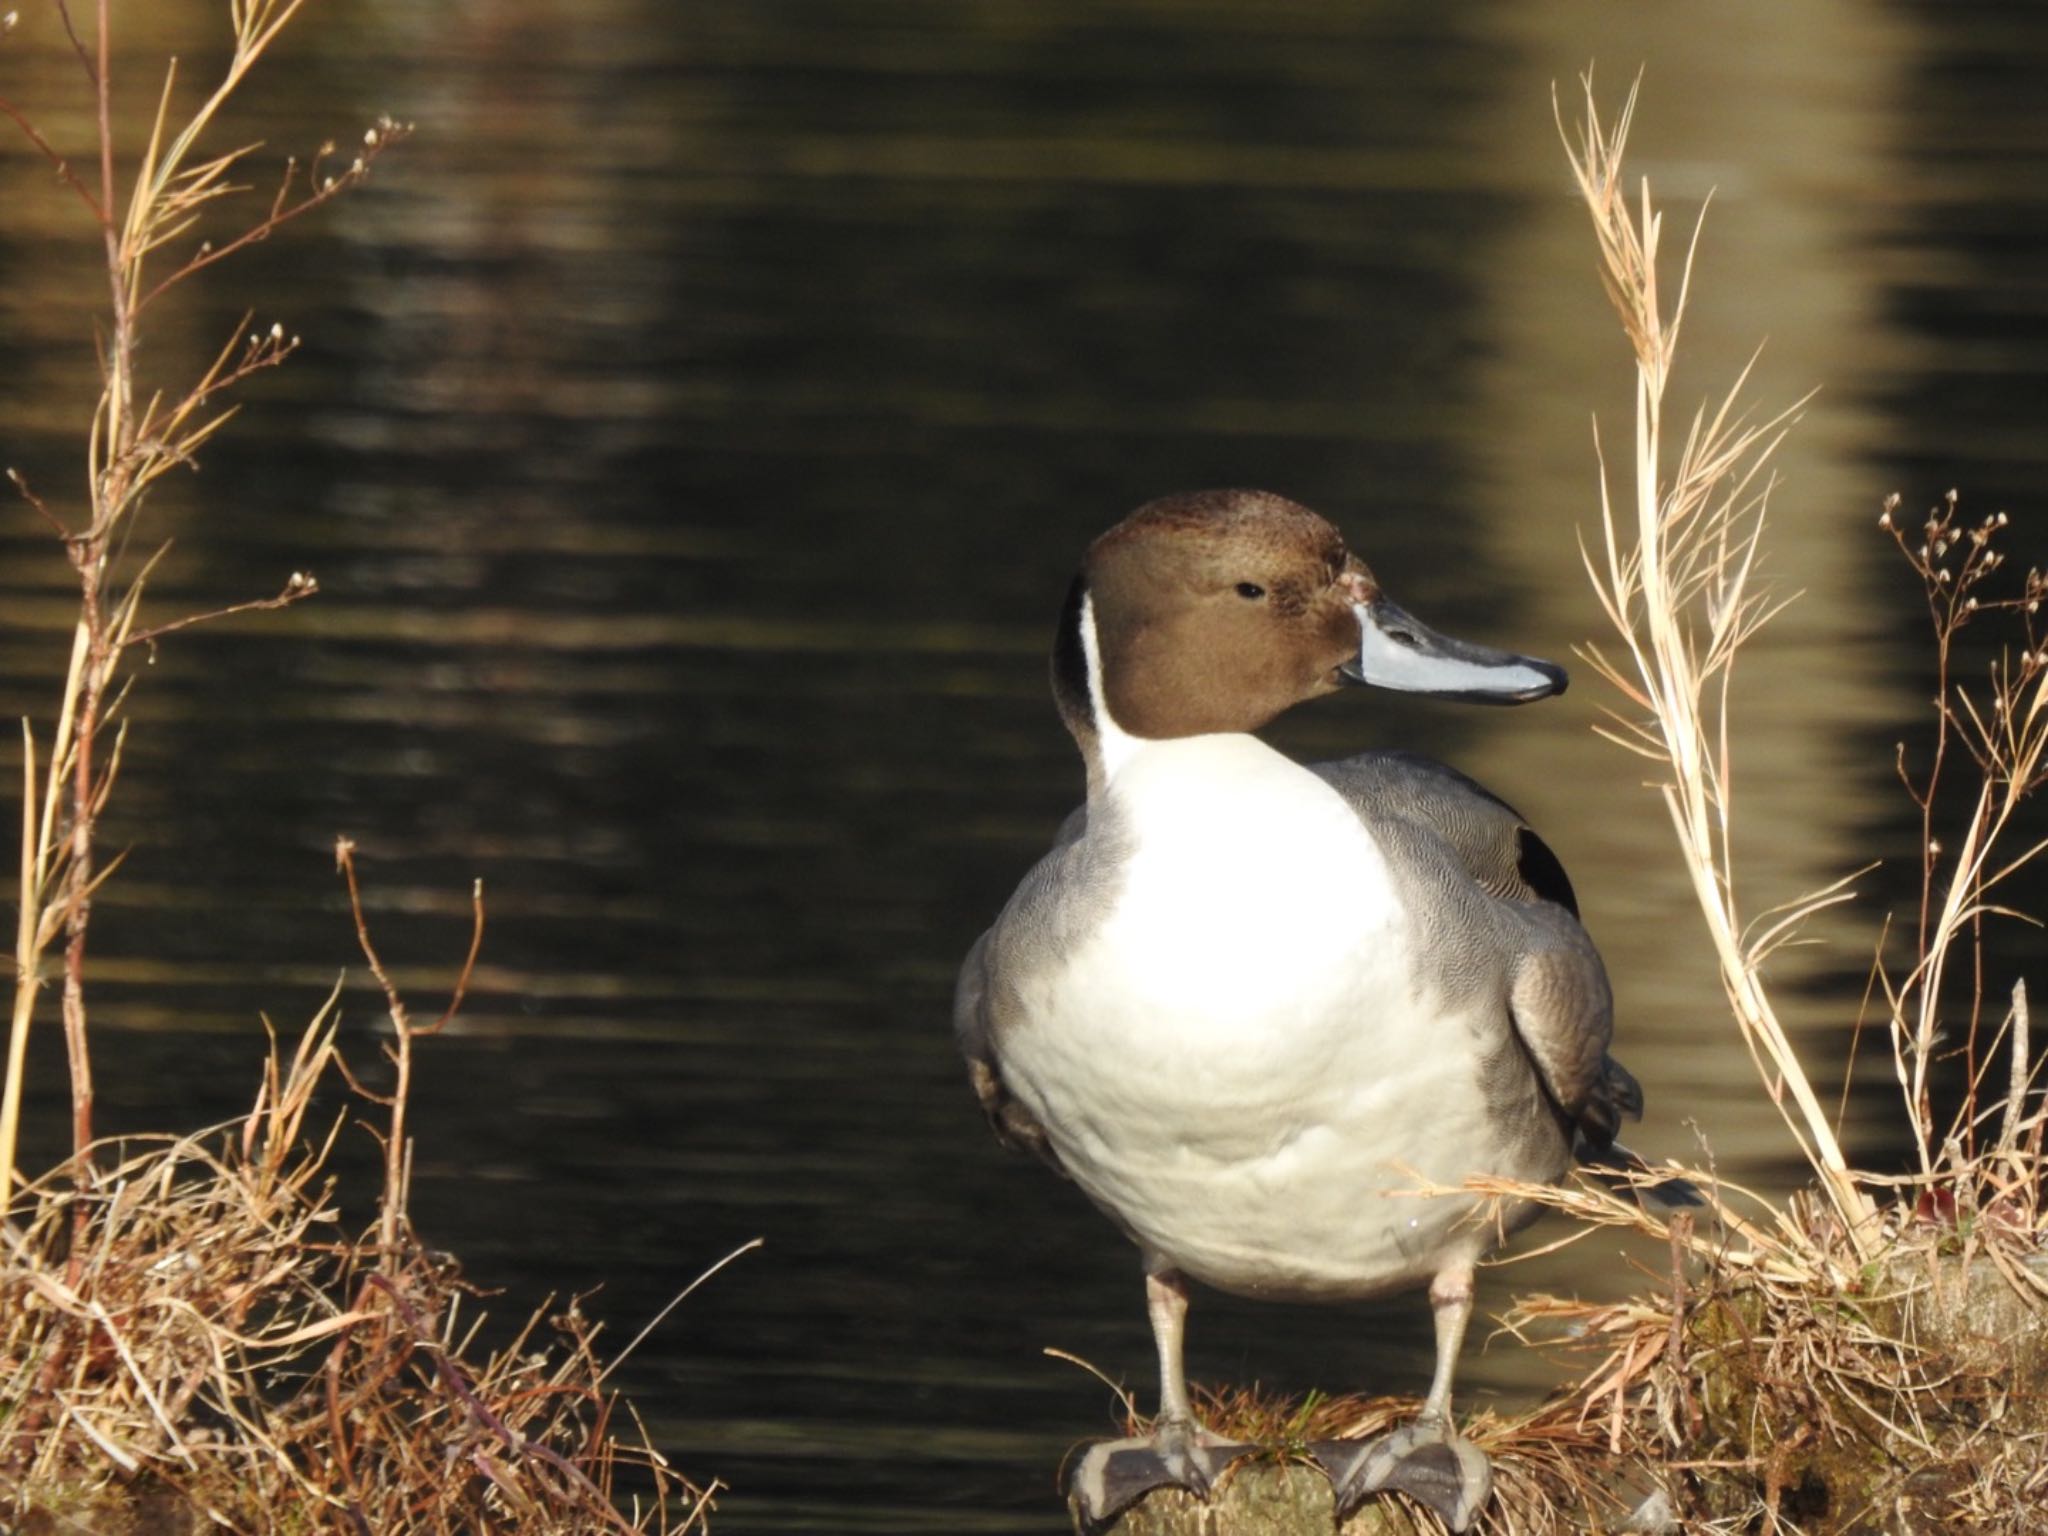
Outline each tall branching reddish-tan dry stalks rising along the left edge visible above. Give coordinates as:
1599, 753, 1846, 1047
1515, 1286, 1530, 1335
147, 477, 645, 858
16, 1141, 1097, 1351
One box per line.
0, 0, 408, 1212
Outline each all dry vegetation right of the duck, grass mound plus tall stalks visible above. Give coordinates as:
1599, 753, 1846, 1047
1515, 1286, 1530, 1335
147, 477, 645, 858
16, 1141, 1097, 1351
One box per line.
1449, 75, 2048, 1532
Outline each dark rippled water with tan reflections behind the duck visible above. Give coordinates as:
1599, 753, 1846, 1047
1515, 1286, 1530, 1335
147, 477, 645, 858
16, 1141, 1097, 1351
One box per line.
0, 0, 2048, 1532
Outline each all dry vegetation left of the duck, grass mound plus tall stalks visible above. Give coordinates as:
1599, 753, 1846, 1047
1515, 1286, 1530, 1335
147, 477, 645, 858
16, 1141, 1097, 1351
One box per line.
0, 0, 709, 1536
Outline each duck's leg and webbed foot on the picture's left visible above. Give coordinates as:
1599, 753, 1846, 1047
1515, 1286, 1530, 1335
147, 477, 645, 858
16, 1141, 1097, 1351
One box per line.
1069, 1255, 1255, 1528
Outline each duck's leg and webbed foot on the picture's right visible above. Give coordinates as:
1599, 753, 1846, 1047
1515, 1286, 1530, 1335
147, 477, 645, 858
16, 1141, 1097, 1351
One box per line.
1325, 1260, 1493, 1530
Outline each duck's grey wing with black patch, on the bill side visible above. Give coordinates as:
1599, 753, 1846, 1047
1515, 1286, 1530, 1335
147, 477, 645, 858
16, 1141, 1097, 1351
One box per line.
1313, 752, 1642, 1149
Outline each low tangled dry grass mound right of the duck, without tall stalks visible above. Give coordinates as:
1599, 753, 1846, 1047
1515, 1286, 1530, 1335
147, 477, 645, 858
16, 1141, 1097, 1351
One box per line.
1505, 1180, 2048, 1532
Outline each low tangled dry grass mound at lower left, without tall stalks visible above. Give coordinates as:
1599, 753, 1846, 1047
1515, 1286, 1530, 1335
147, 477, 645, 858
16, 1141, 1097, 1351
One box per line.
0, 897, 711, 1536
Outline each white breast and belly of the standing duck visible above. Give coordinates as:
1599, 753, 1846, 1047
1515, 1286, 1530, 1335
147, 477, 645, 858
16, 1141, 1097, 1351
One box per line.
1004, 735, 1491, 1296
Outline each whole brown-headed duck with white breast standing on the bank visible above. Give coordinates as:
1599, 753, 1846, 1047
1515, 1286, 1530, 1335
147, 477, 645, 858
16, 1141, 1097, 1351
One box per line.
954, 492, 1642, 1530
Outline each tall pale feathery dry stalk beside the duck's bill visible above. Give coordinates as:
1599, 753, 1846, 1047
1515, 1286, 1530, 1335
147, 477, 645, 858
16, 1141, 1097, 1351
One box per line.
1559, 78, 1874, 1255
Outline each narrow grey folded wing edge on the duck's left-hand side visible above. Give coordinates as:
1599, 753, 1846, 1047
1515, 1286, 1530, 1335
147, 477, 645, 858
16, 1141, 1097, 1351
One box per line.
952, 807, 1087, 1174
